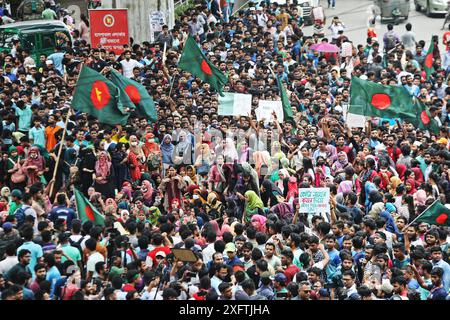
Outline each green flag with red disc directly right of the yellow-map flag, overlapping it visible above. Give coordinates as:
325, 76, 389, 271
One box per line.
110, 70, 158, 121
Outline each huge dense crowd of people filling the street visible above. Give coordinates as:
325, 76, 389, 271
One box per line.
0, 0, 450, 300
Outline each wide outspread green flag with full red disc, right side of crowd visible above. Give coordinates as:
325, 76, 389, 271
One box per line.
348, 77, 417, 121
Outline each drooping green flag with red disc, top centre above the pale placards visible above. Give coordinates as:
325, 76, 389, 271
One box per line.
178, 36, 228, 96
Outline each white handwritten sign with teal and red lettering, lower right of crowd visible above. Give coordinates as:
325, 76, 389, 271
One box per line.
298, 188, 330, 213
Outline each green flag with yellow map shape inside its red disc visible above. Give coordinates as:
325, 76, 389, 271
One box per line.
72, 66, 130, 125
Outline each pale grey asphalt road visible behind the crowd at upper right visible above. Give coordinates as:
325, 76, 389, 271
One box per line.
304, 0, 448, 53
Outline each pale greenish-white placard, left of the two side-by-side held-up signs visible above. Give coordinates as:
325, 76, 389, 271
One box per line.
217, 92, 252, 117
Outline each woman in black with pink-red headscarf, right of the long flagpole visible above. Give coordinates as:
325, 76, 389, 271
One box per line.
92, 151, 115, 198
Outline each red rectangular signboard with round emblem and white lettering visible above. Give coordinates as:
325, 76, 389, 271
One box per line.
89, 9, 129, 54
